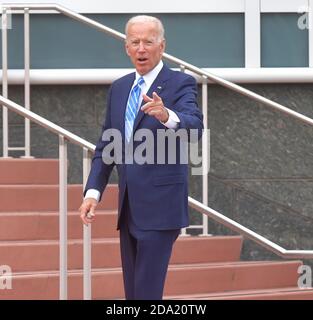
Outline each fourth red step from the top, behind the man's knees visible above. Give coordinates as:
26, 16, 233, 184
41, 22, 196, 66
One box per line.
0, 236, 242, 272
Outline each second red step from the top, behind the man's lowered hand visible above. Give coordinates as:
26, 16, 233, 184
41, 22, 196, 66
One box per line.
0, 185, 118, 212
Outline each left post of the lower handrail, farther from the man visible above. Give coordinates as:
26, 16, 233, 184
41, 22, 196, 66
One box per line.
59, 135, 67, 300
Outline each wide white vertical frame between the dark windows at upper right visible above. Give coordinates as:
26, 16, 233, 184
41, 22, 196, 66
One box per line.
245, 0, 261, 68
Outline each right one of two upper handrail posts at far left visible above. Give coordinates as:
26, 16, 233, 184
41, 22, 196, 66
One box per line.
24, 8, 30, 157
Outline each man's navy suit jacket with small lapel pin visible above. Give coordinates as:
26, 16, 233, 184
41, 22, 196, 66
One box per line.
85, 65, 203, 230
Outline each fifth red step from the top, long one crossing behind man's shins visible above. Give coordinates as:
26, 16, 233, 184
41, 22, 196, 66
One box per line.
0, 261, 301, 299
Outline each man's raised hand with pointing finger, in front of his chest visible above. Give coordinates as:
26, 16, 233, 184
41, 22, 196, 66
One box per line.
141, 92, 169, 123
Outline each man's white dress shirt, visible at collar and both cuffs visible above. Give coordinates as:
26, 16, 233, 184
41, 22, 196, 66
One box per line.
85, 60, 180, 201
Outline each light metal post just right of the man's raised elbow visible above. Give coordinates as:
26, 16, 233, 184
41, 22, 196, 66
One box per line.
202, 77, 209, 236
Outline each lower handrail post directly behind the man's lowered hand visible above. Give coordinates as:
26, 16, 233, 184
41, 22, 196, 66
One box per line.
83, 148, 92, 300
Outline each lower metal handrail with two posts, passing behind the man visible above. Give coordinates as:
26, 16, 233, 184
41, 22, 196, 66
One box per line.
0, 95, 313, 299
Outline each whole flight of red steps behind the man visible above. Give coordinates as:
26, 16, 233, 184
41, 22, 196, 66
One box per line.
0, 159, 313, 299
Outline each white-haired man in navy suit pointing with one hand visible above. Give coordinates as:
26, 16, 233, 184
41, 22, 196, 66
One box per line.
80, 16, 203, 299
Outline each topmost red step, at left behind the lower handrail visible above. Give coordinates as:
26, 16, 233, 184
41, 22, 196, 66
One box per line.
0, 158, 59, 184
